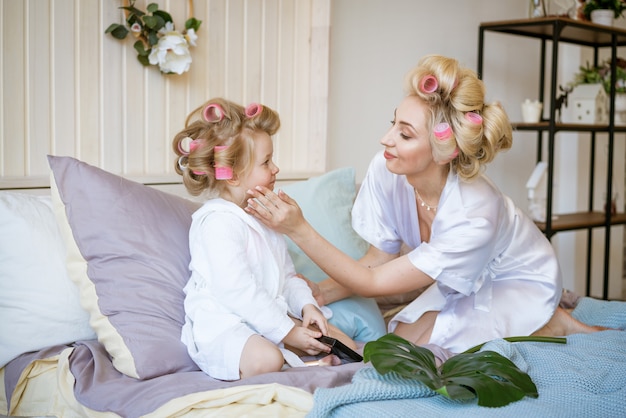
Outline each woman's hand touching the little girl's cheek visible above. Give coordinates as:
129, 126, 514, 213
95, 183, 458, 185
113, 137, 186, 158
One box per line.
244, 186, 306, 235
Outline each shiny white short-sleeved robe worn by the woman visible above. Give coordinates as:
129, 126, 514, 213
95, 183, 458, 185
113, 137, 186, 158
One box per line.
352, 152, 562, 353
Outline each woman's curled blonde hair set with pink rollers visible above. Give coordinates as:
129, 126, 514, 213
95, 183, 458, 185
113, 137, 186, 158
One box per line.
405, 55, 513, 180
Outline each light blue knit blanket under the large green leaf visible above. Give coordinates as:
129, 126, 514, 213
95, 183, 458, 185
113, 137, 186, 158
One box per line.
308, 298, 626, 418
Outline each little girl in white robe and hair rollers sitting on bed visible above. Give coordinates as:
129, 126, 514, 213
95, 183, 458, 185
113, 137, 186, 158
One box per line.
173, 99, 356, 380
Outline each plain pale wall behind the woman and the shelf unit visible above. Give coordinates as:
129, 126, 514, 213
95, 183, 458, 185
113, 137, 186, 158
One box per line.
327, 0, 624, 297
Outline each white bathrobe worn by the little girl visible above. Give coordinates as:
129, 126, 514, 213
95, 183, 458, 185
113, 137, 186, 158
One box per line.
181, 199, 317, 380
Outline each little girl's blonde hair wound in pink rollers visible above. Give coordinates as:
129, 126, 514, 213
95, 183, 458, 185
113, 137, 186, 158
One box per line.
172, 98, 280, 196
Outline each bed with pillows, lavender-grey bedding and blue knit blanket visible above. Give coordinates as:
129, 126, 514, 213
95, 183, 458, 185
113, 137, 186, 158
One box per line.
0, 156, 626, 417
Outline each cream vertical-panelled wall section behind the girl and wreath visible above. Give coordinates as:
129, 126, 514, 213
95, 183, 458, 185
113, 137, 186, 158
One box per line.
0, 0, 330, 188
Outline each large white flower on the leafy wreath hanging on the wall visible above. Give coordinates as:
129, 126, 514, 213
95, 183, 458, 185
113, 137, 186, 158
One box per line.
148, 30, 191, 74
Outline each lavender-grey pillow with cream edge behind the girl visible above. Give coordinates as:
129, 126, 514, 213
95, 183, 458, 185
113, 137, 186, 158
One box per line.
48, 156, 199, 379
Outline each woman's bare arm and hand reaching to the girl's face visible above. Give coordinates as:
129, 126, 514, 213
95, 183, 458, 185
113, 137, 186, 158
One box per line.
246, 187, 433, 297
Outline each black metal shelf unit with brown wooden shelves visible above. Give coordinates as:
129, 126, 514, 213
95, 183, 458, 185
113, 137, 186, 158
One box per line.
477, 16, 626, 299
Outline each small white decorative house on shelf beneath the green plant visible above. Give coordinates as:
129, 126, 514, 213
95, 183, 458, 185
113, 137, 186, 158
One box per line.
568, 84, 608, 124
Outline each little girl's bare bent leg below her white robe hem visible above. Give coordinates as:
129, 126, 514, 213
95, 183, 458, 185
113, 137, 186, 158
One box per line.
239, 334, 285, 379
